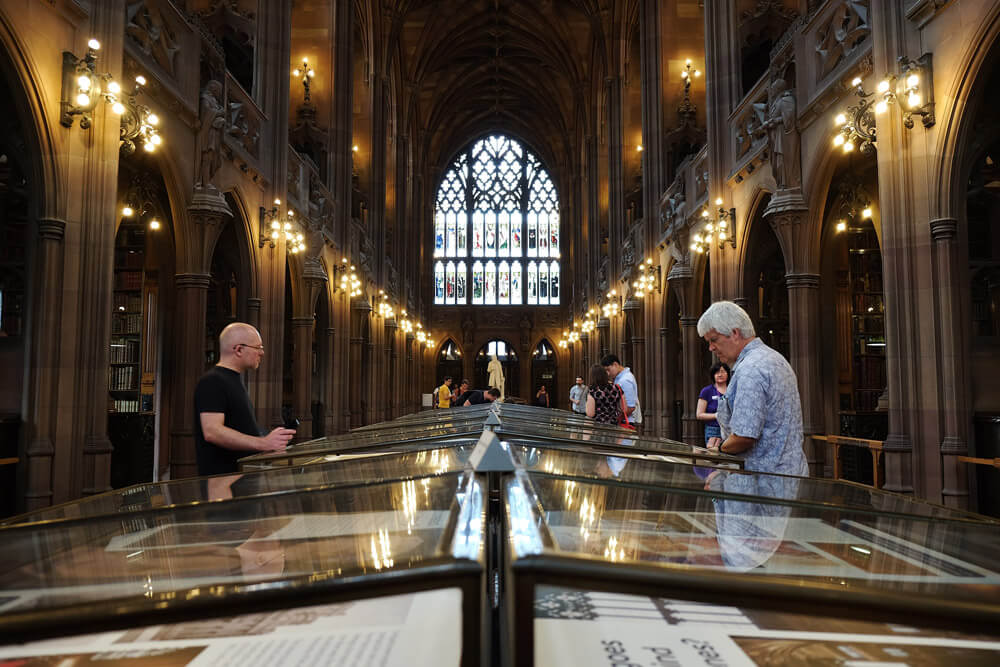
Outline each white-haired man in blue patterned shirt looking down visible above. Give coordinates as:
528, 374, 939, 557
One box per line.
698, 301, 809, 476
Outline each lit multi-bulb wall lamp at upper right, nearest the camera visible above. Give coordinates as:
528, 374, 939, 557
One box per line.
833, 53, 936, 153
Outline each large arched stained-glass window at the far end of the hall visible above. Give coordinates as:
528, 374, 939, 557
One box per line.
432, 135, 560, 305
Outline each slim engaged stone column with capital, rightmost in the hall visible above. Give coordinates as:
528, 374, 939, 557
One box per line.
931, 218, 969, 509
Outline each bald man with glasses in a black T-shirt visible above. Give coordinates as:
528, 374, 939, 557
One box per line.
194, 322, 295, 475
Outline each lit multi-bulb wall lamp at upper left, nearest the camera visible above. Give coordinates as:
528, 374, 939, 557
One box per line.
59, 39, 163, 155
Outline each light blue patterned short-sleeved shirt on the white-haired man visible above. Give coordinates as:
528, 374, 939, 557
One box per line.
716, 338, 809, 476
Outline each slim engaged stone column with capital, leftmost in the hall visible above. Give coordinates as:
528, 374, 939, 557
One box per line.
24, 218, 66, 512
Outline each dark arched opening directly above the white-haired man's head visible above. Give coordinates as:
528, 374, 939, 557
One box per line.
743, 196, 790, 359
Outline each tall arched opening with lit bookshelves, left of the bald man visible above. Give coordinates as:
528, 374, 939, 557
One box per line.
108, 159, 176, 488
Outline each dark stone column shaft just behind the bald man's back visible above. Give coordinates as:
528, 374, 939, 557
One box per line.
164, 273, 211, 479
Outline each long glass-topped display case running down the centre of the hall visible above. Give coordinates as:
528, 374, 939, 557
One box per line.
0, 404, 1000, 667
